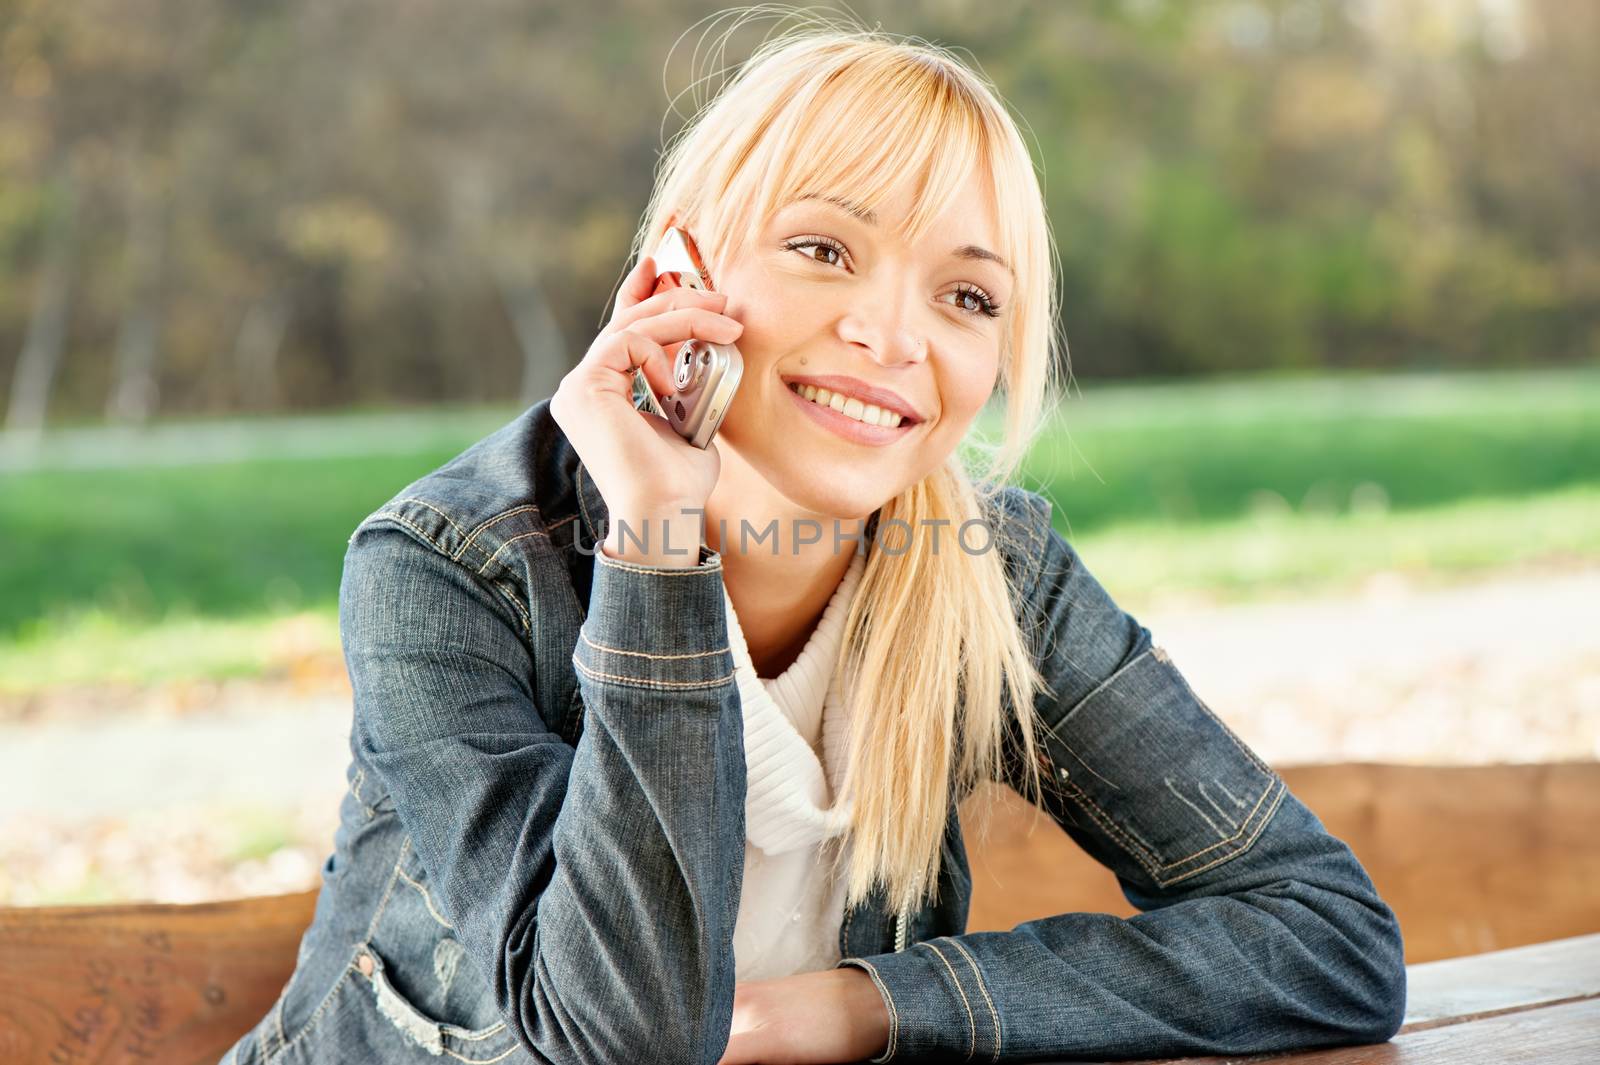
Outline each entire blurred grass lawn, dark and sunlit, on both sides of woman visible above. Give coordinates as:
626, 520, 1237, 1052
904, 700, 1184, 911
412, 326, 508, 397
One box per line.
0, 369, 1600, 691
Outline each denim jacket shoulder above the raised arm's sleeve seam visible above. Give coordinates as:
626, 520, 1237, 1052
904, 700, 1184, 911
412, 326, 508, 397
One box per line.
350, 398, 581, 577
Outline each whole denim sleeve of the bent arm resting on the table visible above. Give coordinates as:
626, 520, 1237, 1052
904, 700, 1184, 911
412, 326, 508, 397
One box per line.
840, 501, 1405, 1062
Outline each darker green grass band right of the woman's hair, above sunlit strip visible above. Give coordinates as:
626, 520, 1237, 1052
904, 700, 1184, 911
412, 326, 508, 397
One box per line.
998, 362, 1600, 534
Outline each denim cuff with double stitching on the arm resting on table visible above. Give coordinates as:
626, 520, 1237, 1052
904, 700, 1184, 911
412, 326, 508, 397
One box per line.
835, 935, 1002, 1062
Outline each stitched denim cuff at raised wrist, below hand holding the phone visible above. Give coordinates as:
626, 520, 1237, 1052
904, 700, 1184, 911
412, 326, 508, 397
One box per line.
573, 544, 733, 689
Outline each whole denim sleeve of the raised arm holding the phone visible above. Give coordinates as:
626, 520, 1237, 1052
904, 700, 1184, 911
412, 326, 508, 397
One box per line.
339, 520, 746, 1062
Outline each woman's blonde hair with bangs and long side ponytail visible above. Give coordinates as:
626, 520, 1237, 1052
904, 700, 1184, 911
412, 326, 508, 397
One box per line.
634, 8, 1058, 911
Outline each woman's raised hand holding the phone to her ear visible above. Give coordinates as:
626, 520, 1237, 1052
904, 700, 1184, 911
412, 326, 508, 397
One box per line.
550, 256, 744, 566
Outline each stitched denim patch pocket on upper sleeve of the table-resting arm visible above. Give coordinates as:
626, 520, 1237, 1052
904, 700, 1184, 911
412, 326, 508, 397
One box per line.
1045, 646, 1285, 888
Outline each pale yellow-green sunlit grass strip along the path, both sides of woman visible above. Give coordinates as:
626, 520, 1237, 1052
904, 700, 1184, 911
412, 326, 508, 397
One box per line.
0, 488, 1600, 694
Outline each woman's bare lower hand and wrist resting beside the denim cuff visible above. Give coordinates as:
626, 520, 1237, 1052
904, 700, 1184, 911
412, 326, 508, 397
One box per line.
718, 966, 890, 1065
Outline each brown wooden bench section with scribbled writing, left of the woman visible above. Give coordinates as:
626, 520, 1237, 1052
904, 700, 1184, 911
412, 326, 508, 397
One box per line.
0, 891, 317, 1065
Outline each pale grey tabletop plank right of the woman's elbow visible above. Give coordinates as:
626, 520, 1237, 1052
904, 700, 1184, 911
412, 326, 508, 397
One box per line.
1402, 935, 1600, 1031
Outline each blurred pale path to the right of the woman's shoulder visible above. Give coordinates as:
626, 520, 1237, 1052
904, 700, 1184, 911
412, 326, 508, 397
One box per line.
1141, 568, 1600, 764
